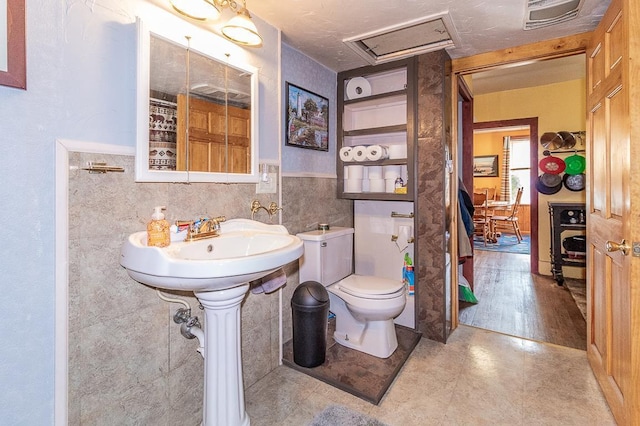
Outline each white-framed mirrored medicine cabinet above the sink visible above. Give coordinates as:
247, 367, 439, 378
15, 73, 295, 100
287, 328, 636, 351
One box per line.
136, 19, 258, 182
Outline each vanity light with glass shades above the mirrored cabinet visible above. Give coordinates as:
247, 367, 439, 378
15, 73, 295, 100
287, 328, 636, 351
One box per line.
169, 0, 262, 46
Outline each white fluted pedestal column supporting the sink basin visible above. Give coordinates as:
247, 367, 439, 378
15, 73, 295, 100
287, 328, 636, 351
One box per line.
194, 284, 251, 426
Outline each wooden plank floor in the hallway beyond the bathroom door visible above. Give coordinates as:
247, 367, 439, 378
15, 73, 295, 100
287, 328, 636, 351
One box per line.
459, 250, 587, 349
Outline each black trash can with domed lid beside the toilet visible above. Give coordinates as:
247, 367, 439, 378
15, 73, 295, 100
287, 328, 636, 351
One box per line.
291, 281, 329, 368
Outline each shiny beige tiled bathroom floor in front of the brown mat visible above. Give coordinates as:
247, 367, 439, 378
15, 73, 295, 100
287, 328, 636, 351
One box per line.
246, 325, 615, 426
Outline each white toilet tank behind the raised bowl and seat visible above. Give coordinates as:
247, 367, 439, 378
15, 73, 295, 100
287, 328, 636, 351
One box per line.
297, 226, 353, 287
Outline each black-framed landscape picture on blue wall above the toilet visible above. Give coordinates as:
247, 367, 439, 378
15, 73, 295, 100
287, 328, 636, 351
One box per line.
285, 82, 329, 151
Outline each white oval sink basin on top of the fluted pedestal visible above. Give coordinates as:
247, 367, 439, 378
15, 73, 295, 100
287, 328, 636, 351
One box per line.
120, 219, 304, 291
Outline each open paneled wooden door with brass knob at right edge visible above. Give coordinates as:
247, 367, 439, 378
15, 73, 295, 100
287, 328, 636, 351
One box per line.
587, 0, 640, 425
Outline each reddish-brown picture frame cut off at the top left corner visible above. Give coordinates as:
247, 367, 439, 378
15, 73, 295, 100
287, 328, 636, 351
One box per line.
0, 0, 27, 89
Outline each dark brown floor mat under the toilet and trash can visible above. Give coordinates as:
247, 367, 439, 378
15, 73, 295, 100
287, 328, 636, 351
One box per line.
282, 320, 422, 405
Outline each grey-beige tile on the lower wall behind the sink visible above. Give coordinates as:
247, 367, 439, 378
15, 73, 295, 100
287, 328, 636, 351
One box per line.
69, 153, 352, 425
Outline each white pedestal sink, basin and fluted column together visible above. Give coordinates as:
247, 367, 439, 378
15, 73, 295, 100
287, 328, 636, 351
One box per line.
120, 219, 304, 426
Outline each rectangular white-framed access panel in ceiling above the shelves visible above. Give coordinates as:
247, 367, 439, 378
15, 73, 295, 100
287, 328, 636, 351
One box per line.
342, 13, 460, 65
